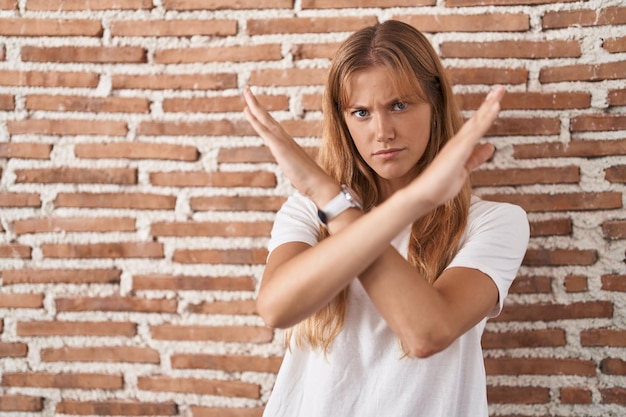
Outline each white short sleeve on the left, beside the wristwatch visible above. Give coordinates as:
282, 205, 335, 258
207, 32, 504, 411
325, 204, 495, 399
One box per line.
268, 193, 320, 253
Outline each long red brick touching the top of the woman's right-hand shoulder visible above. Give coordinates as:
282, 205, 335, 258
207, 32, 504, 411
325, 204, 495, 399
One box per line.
483, 192, 622, 212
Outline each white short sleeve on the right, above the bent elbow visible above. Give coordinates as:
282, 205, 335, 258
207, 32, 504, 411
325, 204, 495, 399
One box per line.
448, 198, 530, 317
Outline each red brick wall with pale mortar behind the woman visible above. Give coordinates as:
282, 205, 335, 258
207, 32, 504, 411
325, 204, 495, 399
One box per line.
0, 0, 626, 417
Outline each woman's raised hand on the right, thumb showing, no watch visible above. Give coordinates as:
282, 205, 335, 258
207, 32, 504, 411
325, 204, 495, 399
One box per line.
409, 86, 505, 208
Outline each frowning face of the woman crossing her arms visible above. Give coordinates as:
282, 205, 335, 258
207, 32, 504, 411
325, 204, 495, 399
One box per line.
343, 66, 432, 196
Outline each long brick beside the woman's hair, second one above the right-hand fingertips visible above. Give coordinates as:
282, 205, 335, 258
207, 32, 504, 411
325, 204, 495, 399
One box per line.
440, 40, 581, 59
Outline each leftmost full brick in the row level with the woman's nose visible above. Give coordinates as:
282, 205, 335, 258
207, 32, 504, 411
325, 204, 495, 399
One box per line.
7, 119, 128, 136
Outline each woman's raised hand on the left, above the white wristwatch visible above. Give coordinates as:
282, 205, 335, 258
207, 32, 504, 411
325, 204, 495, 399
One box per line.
243, 87, 339, 207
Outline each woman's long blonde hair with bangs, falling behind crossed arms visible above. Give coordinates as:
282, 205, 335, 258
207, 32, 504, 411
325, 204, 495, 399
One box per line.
286, 20, 471, 352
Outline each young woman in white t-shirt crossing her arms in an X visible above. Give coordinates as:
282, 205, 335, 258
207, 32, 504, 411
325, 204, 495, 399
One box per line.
244, 21, 529, 417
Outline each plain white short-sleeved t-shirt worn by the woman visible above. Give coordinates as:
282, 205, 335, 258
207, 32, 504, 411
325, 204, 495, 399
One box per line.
264, 194, 529, 417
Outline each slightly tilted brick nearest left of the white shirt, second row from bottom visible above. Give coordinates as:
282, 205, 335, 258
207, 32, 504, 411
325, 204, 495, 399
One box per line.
137, 376, 261, 399
